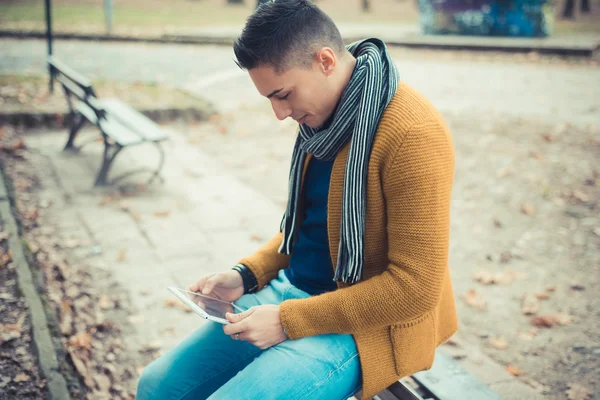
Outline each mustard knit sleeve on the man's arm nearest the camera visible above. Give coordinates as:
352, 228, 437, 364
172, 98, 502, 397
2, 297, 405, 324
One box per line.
280, 119, 454, 339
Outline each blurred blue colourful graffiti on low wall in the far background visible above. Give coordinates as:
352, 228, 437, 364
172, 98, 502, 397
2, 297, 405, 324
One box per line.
419, 0, 554, 37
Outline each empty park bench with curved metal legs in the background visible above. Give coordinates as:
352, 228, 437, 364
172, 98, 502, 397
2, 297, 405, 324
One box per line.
48, 57, 168, 186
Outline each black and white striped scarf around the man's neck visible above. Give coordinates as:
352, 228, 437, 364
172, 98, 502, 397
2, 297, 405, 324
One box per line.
279, 39, 399, 283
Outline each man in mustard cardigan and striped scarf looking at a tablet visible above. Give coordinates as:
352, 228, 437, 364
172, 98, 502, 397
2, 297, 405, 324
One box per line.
138, 0, 457, 400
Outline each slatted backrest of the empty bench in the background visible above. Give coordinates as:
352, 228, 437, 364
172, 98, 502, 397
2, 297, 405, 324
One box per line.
48, 56, 104, 118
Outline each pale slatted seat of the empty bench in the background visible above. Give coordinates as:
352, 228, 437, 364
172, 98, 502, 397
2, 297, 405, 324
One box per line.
100, 98, 167, 142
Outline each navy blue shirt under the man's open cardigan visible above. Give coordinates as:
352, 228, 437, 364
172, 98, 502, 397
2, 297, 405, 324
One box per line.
285, 157, 337, 295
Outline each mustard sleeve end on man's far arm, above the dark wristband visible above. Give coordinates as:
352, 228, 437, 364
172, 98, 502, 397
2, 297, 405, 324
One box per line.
238, 232, 290, 290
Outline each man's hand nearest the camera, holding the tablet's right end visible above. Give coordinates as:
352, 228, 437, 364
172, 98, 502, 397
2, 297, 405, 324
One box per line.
223, 304, 288, 350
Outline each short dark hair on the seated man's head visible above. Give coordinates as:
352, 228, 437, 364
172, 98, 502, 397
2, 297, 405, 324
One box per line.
233, 0, 344, 73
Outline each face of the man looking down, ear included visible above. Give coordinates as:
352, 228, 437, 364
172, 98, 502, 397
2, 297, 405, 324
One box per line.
248, 55, 338, 128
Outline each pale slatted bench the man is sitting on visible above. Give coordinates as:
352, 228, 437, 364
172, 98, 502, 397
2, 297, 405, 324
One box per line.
354, 351, 502, 400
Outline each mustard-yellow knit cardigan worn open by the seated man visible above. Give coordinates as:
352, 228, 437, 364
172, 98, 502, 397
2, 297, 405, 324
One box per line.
239, 83, 458, 400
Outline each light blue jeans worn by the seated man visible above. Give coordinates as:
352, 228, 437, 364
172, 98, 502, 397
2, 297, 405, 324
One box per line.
136, 270, 361, 400
